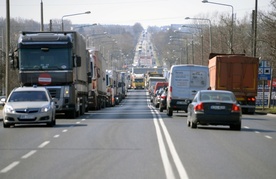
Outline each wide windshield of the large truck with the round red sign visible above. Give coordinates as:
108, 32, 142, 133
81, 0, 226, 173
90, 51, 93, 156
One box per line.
19, 48, 72, 71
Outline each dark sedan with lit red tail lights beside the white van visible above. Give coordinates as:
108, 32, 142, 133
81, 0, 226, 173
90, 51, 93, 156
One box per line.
187, 90, 241, 130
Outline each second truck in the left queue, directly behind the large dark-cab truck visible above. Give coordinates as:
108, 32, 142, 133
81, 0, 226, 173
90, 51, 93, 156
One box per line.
88, 49, 108, 110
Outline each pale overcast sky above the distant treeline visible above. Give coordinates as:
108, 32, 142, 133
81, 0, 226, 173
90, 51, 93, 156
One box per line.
0, 0, 271, 27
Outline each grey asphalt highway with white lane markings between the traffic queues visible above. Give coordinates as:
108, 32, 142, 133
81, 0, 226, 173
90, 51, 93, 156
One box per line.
0, 90, 276, 179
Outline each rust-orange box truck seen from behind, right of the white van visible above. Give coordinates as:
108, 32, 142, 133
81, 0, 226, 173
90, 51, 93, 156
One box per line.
208, 54, 259, 114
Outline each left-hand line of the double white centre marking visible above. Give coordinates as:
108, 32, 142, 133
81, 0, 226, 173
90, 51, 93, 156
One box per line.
152, 112, 175, 179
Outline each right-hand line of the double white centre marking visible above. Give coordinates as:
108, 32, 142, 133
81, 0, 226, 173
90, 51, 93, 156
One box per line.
158, 114, 189, 179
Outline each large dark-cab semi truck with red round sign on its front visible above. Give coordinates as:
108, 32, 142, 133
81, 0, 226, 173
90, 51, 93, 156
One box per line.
10, 31, 89, 118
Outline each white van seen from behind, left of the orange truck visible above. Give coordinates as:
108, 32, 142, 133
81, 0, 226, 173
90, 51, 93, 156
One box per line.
167, 64, 210, 116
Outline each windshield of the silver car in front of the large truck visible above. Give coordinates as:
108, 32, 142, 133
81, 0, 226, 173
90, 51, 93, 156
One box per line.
9, 91, 48, 102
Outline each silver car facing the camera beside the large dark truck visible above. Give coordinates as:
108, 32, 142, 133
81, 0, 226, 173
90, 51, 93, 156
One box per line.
3, 86, 56, 128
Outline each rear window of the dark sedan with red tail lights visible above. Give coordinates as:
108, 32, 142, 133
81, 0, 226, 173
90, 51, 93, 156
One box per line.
200, 92, 236, 102
